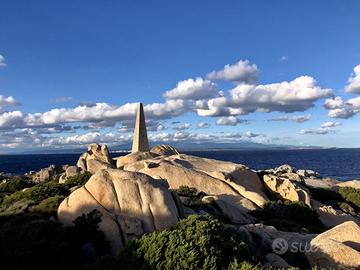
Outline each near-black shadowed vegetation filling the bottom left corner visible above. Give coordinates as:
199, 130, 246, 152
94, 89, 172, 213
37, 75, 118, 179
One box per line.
0, 212, 108, 269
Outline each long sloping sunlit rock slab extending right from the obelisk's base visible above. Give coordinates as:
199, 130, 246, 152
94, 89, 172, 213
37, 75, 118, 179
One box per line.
124, 154, 268, 207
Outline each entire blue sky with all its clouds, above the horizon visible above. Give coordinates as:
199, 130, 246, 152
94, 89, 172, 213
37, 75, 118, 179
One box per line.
0, 0, 360, 153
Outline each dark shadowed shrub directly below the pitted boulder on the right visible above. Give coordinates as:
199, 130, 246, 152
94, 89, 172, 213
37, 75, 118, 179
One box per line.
249, 201, 325, 232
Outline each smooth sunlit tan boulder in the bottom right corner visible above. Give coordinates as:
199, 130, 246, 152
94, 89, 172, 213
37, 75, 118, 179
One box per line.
306, 221, 360, 269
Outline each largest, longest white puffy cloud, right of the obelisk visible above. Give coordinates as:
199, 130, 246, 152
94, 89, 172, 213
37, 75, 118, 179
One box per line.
197, 76, 332, 116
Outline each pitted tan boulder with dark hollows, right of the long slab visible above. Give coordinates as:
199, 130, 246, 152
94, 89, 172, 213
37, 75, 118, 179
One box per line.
264, 175, 311, 207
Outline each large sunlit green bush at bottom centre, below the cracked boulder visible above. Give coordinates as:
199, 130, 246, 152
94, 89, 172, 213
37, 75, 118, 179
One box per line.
91, 215, 256, 270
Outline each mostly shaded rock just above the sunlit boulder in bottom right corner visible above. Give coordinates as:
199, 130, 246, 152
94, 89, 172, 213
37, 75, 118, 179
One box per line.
311, 200, 360, 228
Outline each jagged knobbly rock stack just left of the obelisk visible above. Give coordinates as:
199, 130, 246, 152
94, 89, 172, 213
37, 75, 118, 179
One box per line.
76, 143, 114, 174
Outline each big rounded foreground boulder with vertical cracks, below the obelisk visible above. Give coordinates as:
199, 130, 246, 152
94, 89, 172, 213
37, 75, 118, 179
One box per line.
58, 169, 179, 252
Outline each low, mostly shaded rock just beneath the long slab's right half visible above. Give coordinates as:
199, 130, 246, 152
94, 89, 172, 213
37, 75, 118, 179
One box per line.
202, 195, 258, 224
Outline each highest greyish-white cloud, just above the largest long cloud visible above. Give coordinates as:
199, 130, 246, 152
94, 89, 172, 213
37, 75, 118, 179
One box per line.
206, 60, 259, 84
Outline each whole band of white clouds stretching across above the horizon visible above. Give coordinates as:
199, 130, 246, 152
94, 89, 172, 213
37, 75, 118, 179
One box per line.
0, 59, 360, 150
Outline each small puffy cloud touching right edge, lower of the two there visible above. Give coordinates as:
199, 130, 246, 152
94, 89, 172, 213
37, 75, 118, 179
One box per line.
324, 97, 360, 119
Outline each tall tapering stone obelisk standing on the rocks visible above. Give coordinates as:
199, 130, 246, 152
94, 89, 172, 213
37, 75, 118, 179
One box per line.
131, 103, 150, 153
